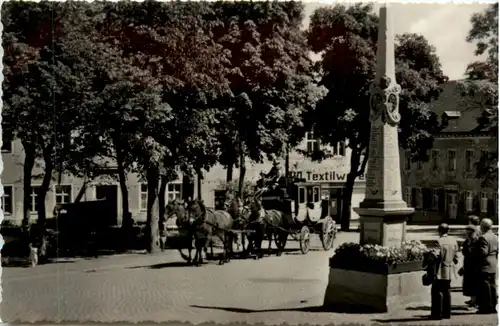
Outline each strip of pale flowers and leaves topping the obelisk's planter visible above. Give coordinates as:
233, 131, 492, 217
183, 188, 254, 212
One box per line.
332, 240, 428, 265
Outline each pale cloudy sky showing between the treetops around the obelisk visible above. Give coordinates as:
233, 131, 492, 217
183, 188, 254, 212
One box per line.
304, 2, 489, 80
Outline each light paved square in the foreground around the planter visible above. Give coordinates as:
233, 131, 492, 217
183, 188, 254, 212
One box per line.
0, 233, 498, 325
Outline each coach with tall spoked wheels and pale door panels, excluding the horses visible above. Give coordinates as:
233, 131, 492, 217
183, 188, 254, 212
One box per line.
252, 178, 337, 254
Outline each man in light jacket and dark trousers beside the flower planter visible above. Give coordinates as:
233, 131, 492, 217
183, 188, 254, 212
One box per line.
431, 223, 458, 320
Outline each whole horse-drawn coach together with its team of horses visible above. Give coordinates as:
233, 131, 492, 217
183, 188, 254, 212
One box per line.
170, 174, 336, 264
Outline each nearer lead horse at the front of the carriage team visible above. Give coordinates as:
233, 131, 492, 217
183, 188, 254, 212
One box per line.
187, 200, 233, 265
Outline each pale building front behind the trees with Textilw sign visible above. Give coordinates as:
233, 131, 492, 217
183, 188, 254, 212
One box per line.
1, 134, 364, 225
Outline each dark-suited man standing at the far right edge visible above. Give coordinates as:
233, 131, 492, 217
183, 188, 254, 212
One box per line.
476, 218, 498, 314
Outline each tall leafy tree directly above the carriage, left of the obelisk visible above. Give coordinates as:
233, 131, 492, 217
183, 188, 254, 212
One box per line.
210, 1, 324, 195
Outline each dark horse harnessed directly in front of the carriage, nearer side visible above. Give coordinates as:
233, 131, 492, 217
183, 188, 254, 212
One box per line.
250, 196, 289, 256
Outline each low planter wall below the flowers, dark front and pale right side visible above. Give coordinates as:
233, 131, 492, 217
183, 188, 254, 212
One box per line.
324, 262, 430, 312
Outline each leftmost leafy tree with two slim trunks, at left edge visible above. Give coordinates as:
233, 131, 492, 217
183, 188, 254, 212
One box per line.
2, 1, 98, 239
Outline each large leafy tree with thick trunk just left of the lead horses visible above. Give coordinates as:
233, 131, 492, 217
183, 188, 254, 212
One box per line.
91, 1, 229, 252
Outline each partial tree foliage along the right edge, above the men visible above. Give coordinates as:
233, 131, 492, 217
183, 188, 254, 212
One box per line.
460, 3, 498, 185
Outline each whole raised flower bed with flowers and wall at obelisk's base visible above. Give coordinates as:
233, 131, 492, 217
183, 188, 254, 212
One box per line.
324, 241, 430, 312
